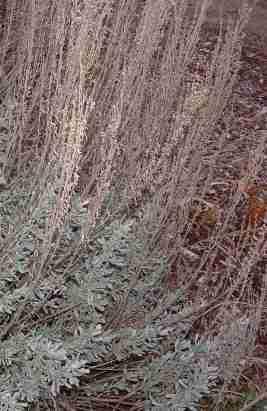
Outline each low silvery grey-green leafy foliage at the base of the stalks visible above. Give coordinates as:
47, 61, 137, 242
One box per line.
0, 169, 220, 411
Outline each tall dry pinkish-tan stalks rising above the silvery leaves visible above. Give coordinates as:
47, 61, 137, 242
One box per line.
0, 0, 266, 410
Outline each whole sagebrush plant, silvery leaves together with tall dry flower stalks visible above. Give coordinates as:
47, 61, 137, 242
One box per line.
0, 0, 260, 411
